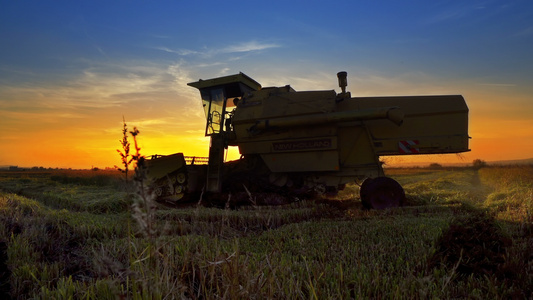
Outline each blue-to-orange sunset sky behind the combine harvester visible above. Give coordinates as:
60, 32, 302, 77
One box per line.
0, 0, 533, 168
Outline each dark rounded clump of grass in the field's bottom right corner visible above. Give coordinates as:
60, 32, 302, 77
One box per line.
428, 210, 533, 299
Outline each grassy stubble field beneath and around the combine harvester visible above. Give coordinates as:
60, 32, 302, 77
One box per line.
0, 166, 533, 299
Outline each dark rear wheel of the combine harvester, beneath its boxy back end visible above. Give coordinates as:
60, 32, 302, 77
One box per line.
360, 177, 405, 209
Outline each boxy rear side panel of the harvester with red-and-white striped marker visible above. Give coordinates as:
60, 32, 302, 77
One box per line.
338, 95, 470, 155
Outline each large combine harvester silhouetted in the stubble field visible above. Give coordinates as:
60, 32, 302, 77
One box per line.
148, 72, 469, 209
